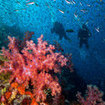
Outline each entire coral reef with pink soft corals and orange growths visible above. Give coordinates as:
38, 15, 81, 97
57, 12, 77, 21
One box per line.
0, 31, 105, 105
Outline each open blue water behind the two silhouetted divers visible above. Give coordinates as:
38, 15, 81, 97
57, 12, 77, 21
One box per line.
0, 0, 105, 92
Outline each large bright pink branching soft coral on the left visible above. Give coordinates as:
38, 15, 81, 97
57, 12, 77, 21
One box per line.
0, 35, 68, 101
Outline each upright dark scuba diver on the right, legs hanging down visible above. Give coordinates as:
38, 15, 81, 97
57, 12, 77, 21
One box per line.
78, 24, 91, 48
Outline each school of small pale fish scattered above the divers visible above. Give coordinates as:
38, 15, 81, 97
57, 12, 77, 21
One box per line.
1, 0, 104, 33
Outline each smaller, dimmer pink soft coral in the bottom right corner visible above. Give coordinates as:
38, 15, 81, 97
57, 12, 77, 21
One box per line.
77, 85, 105, 105
